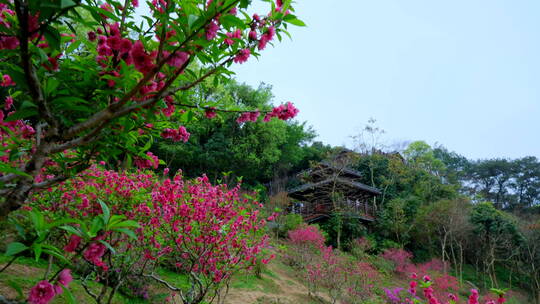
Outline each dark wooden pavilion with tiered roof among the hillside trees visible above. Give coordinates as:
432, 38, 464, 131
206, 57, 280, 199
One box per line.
288, 157, 381, 223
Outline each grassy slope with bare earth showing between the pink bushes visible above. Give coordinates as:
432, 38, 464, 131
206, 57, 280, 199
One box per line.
0, 255, 527, 304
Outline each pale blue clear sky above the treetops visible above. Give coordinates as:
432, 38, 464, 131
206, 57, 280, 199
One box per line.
233, 0, 540, 159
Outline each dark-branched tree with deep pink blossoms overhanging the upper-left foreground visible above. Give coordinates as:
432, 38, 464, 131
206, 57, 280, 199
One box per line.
0, 0, 303, 217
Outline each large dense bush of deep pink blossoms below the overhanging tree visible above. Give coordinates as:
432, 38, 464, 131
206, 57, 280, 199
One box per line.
6, 166, 271, 303
